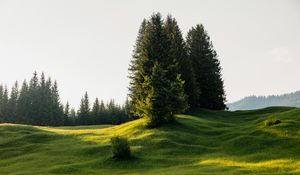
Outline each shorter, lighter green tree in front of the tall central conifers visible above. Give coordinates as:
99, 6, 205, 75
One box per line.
141, 63, 188, 127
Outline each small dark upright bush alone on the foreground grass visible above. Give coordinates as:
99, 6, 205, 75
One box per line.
111, 136, 131, 159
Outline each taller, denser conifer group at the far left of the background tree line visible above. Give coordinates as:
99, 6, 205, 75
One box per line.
0, 72, 64, 125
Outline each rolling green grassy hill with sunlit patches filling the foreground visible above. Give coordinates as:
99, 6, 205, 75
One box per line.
0, 107, 300, 175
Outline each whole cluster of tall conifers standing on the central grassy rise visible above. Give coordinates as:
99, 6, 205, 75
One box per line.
129, 13, 226, 126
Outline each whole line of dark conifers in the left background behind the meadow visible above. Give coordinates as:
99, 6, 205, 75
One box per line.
0, 72, 131, 126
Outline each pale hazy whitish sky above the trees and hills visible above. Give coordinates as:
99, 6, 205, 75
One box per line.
0, 0, 300, 108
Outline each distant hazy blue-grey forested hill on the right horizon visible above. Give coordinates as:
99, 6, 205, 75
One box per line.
227, 91, 300, 111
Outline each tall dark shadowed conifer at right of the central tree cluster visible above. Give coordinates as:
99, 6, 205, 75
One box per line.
186, 25, 226, 110
